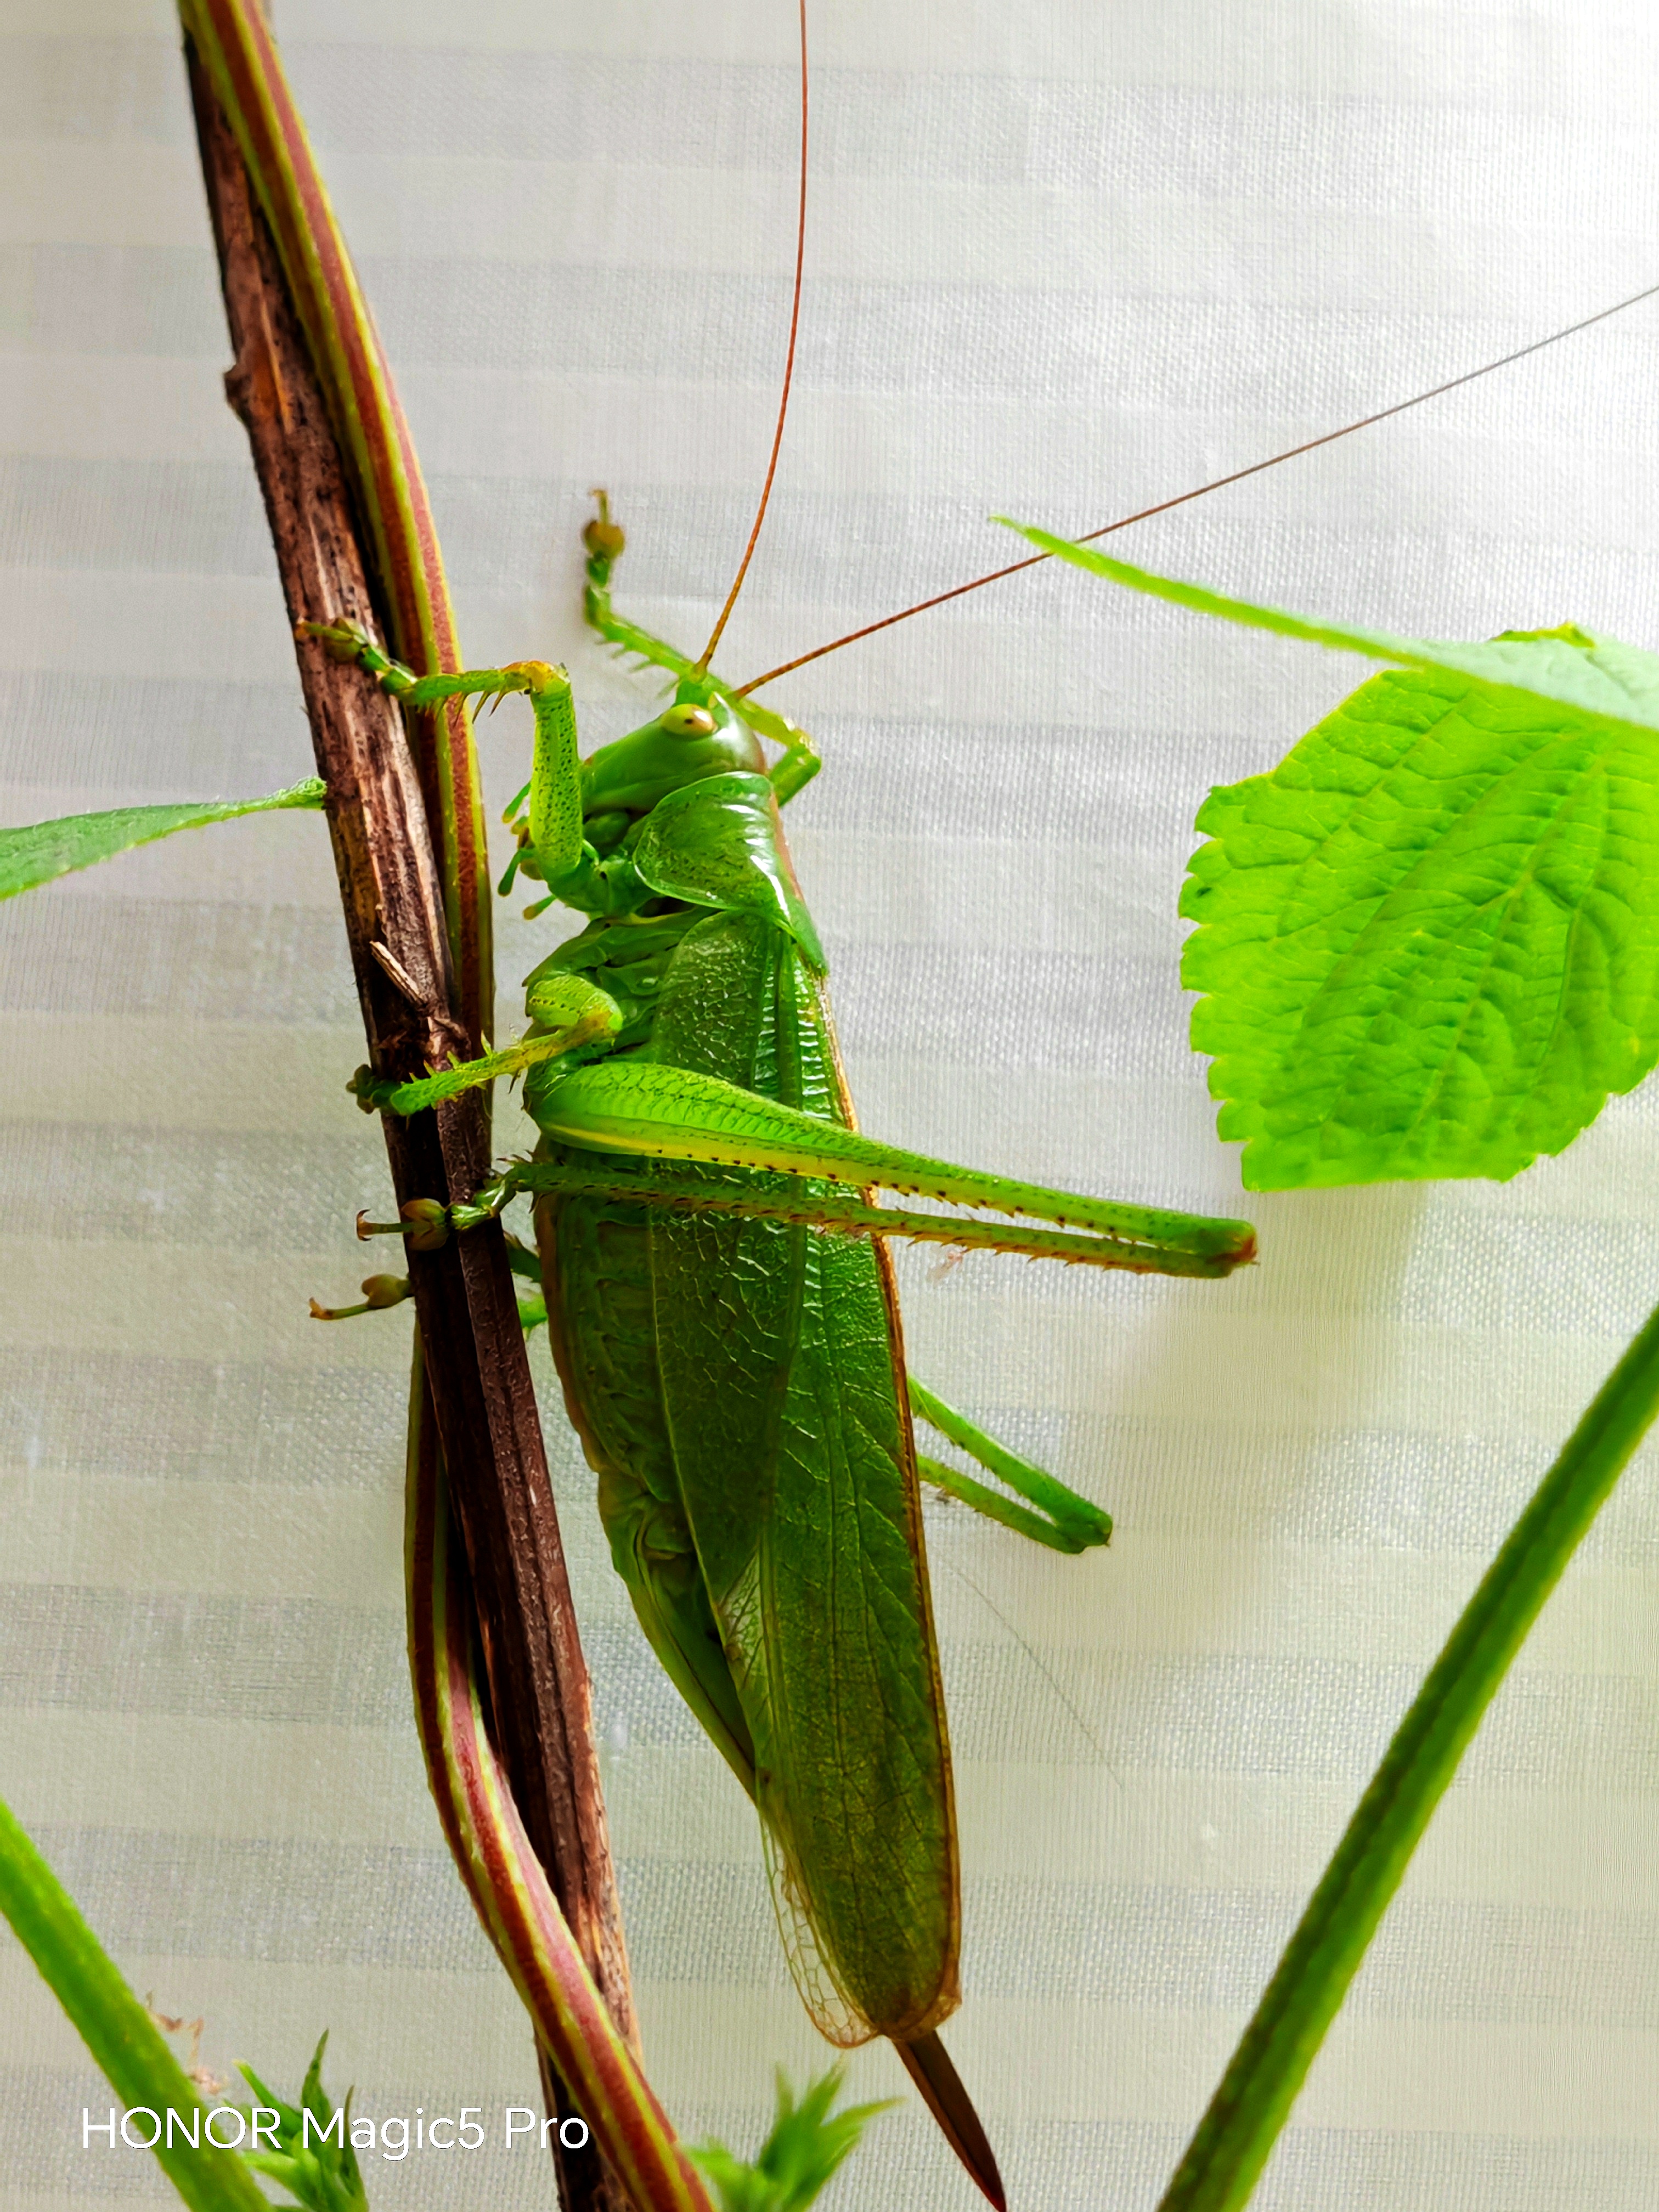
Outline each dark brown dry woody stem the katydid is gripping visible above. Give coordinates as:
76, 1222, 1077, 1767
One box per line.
190, 35, 637, 2212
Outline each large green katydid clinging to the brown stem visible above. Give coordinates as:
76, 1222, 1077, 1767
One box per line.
309, 509, 1254, 2201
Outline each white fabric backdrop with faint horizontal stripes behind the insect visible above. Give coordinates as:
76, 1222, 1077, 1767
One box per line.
0, 0, 1659, 2212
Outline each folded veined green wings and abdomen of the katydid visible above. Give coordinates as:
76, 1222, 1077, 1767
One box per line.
533, 913, 958, 2042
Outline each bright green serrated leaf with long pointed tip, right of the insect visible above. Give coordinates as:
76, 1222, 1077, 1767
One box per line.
1000, 517, 1659, 1190
